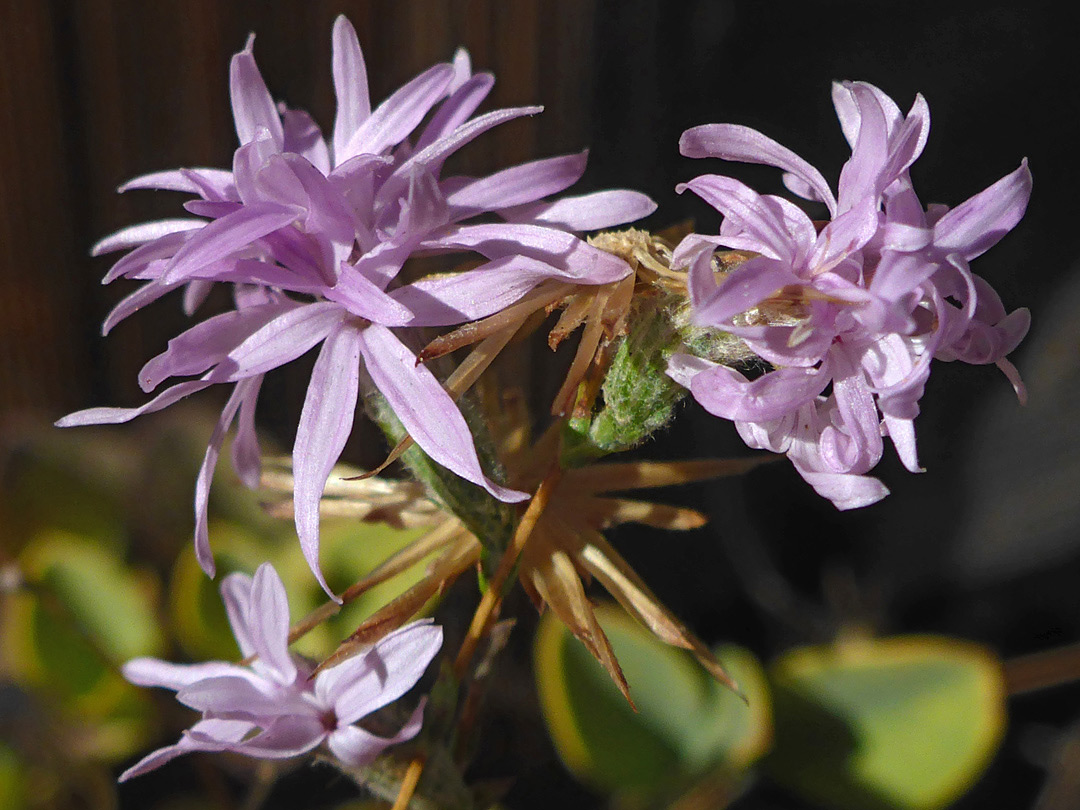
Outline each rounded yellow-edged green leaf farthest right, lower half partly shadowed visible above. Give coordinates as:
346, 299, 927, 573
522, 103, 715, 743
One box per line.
769, 636, 1005, 810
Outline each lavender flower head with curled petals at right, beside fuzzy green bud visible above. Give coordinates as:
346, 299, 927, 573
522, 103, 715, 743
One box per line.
669, 82, 1031, 509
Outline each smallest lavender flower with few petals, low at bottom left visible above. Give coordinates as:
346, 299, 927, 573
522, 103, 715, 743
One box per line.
120, 563, 443, 782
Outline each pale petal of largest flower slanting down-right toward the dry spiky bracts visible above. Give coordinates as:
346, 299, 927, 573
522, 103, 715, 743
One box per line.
360, 324, 528, 503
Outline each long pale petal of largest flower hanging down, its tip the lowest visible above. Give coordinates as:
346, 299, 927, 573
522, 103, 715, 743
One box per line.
293, 323, 362, 599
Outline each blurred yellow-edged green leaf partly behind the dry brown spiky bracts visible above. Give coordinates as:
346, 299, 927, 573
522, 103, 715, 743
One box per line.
534, 606, 770, 797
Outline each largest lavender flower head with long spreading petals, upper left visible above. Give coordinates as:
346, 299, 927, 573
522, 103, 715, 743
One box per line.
59, 17, 656, 588
